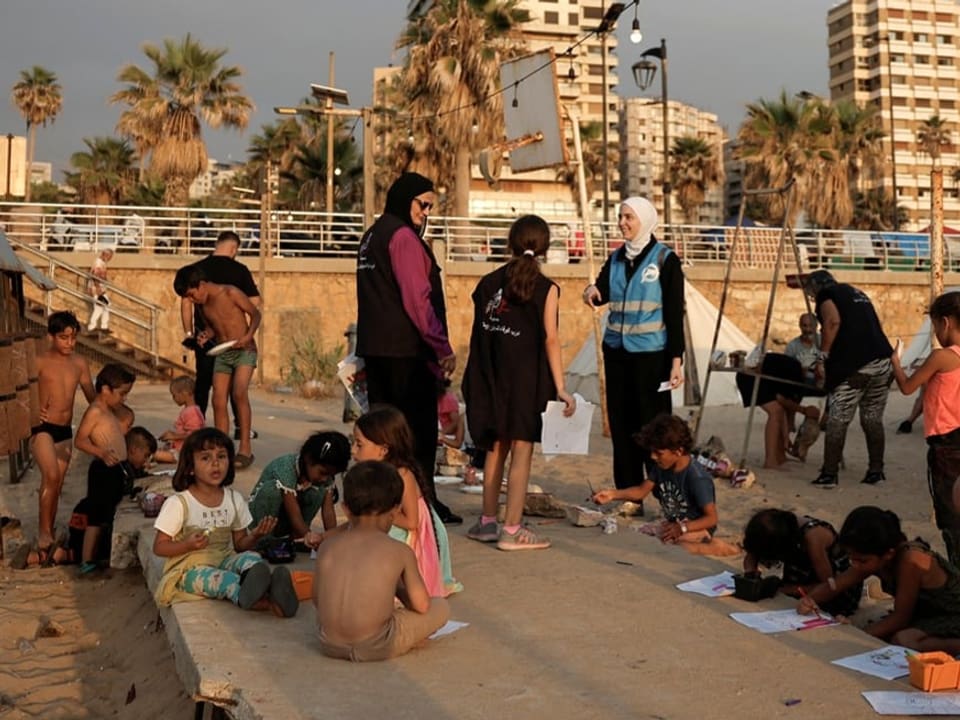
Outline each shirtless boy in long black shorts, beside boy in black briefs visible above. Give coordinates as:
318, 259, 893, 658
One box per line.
76, 363, 136, 575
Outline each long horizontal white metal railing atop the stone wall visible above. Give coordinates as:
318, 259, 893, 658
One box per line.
0, 203, 960, 272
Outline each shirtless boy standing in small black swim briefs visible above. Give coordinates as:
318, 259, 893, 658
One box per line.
30, 311, 95, 554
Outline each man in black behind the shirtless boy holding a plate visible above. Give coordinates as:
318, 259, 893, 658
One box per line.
177, 230, 260, 434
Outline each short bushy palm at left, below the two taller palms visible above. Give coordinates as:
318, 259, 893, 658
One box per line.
66, 137, 136, 205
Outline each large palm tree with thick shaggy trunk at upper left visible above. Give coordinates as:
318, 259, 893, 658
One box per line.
110, 33, 254, 205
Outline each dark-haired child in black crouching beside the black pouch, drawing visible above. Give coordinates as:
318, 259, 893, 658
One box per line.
743, 508, 863, 615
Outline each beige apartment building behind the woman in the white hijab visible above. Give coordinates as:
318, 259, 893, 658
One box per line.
619, 98, 725, 224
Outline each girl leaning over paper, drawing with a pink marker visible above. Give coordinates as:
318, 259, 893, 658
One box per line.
797, 506, 960, 655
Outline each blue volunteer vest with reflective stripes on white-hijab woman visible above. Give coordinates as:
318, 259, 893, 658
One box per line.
603, 242, 671, 352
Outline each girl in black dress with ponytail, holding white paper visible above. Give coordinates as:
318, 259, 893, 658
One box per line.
463, 215, 576, 550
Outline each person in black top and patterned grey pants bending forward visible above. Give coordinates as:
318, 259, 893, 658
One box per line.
803, 270, 893, 488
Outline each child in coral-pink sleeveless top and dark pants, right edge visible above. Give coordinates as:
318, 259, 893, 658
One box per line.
891, 292, 960, 565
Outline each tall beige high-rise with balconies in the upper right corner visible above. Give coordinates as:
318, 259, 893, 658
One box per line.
827, 0, 960, 230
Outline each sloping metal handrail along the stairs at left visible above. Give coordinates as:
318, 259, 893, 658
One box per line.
10, 238, 163, 367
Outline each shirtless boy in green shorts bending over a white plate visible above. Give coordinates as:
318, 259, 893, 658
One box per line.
174, 266, 260, 470
